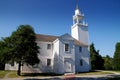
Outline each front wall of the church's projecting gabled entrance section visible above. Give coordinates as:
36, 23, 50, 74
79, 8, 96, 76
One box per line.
60, 34, 75, 73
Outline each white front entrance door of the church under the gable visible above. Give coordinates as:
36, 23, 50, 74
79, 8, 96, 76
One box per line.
64, 58, 72, 73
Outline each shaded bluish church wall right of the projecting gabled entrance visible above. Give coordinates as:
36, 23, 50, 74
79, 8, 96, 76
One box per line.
75, 46, 90, 72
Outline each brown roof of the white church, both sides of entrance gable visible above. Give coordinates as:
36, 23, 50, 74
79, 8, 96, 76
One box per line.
36, 34, 88, 46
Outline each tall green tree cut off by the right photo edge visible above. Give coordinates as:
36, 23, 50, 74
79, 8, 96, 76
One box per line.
113, 42, 120, 70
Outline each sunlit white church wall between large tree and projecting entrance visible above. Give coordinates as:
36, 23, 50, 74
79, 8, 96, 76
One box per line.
22, 41, 54, 73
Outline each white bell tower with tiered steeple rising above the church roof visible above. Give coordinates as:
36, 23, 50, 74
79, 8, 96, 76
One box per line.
71, 5, 89, 45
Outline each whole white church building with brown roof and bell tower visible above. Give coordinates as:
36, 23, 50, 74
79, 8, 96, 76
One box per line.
5, 7, 90, 74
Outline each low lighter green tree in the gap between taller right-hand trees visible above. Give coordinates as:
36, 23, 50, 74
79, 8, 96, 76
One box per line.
103, 55, 113, 70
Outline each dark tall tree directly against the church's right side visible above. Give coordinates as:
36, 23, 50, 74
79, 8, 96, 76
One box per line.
90, 43, 104, 70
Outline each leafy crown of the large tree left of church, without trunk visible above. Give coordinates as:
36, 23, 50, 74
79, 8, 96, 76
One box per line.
11, 25, 39, 65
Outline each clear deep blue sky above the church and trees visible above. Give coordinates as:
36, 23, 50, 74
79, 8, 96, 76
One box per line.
0, 0, 120, 57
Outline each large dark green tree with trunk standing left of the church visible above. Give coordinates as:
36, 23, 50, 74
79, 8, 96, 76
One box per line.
4, 25, 39, 75
